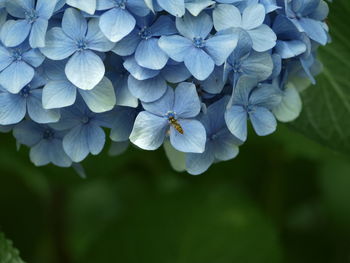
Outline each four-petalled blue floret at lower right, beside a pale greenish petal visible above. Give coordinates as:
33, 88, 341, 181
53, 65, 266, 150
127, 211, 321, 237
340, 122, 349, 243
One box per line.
225, 76, 281, 142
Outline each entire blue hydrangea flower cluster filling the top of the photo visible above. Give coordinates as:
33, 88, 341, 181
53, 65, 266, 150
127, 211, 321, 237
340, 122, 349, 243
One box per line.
0, 0, 329, 174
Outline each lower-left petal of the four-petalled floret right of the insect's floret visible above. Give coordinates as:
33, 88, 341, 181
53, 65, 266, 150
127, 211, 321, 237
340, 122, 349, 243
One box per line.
225, 106, 247, 142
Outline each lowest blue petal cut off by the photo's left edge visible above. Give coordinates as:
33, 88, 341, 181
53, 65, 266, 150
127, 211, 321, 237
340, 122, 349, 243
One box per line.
0, 92, 27, 125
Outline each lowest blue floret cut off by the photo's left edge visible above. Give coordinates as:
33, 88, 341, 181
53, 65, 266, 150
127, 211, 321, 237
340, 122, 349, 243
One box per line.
0, 72, 60, 125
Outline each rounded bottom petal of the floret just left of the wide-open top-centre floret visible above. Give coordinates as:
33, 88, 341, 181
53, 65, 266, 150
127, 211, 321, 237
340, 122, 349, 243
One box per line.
135, 38, 169, 70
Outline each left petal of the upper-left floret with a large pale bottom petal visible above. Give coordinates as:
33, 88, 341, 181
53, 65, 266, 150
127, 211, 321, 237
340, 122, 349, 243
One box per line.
40, 27, 77, 60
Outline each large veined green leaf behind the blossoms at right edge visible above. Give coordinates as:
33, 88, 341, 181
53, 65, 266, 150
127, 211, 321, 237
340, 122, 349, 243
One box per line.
292, 0, 350, 153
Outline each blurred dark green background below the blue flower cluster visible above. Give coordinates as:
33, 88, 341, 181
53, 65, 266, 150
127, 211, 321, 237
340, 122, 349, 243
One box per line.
0, 125, 350, 263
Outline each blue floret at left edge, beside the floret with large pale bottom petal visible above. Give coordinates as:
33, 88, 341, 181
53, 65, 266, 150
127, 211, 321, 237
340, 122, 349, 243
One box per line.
0, 41, 45, 93
